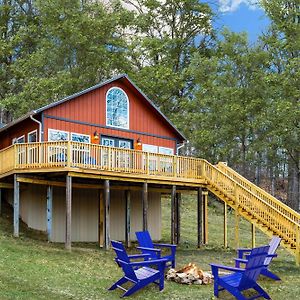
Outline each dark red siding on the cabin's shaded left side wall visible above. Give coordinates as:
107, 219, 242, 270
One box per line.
0, 119, 39, 149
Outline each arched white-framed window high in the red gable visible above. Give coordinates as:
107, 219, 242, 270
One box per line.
106, 87, 129, 129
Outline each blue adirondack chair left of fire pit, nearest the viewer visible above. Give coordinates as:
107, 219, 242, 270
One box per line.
109, 241, 166, 297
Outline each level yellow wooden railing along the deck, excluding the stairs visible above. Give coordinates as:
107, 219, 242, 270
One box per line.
0, 141, 203, 179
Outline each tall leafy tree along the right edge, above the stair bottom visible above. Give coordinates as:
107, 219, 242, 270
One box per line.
262, 0, 300, 210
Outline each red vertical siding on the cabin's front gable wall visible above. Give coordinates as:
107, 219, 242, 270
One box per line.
44, 80, 178, 149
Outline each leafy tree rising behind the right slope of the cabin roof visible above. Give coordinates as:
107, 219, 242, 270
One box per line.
122, 0, 213, 120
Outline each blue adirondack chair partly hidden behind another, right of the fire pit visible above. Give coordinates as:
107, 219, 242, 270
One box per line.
235, 236, 281, 280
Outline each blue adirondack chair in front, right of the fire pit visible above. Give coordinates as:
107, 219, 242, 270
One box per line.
211, 245, 271, 300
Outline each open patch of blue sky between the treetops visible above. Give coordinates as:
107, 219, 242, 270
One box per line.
215, 0, 270, 42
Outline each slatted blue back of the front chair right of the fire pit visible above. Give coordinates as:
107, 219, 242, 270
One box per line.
239, 245, 270, 288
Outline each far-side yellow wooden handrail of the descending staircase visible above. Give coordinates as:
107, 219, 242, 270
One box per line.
217, 162, 300, 224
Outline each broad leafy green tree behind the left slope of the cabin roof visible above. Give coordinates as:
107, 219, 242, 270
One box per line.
2, 0, 130, 116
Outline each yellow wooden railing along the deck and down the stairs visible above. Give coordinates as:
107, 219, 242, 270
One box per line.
0, 141, 300, 255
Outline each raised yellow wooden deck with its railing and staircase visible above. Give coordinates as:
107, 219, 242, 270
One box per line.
0, 141, 300, 264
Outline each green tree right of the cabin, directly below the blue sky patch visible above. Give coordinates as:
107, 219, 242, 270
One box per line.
188, 30, 268, 178
